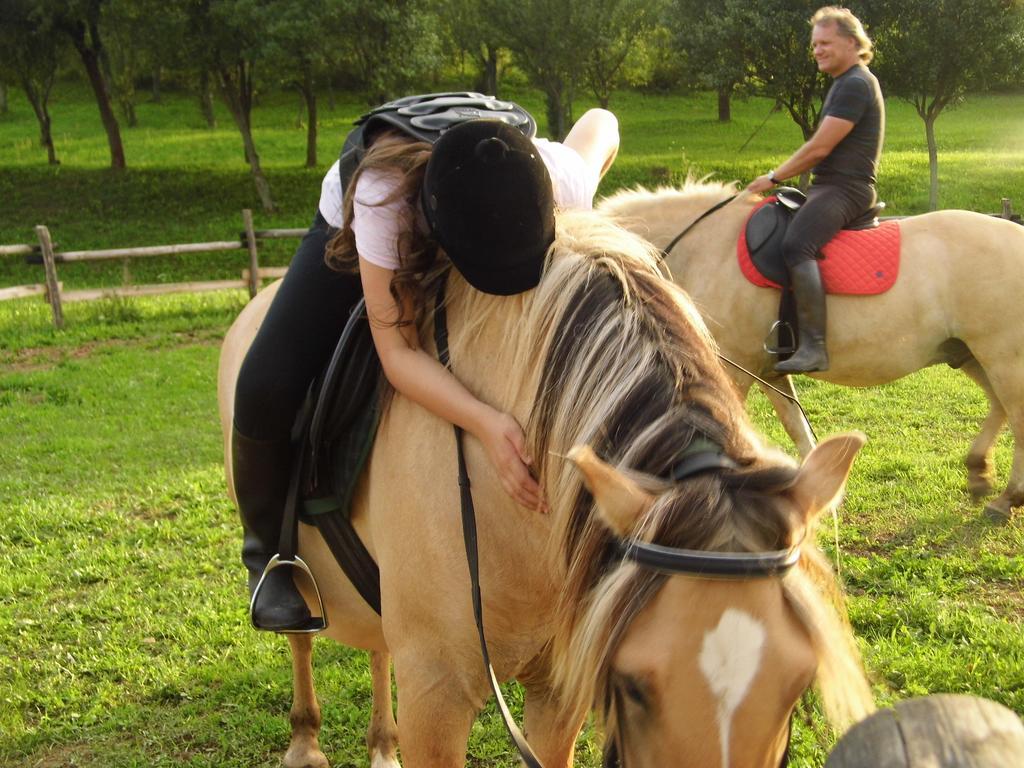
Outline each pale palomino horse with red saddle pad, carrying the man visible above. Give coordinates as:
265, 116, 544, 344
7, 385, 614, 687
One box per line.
601, 181, 1024, 521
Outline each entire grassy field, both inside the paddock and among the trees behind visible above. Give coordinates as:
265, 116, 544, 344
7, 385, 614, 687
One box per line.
0, 83, 1024, 768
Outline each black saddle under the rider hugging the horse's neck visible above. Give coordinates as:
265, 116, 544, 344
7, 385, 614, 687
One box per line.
292, 299, 384, 613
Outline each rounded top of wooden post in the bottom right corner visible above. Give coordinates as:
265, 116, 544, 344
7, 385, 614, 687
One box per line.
825, 693, 1024, 768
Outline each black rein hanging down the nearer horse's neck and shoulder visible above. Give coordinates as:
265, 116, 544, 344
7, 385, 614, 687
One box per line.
434, 279, 544, 768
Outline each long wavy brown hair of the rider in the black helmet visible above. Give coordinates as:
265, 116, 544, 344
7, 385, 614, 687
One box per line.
325, 131, 447, 326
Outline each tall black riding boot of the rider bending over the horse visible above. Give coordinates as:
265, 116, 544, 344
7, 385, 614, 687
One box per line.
231, 427, 309, 632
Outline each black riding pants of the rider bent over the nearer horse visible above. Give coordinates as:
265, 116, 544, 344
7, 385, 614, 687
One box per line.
234, 211, 362, 440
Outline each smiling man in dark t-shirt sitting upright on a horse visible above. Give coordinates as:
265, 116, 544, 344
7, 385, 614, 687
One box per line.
746, 5, 886, 373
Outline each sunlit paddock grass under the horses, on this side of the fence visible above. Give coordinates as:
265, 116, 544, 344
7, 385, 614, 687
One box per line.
0, 299, 1024, 766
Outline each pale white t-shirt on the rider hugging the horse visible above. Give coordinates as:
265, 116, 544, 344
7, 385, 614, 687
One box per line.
319, 138, 600, 269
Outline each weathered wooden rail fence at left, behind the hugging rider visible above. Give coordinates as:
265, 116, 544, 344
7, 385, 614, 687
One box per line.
0, 209, 306, 328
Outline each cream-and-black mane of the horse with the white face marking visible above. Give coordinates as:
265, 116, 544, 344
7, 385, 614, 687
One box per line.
440, 208, 870, 724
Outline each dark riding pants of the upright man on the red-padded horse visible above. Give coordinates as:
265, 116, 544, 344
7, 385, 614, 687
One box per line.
782, 179, 876, 267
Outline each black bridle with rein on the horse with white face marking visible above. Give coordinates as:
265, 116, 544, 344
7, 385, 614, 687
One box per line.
434, 286, 801, 768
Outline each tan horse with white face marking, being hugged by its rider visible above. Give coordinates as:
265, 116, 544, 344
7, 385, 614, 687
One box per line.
219, 213, 871, 768
